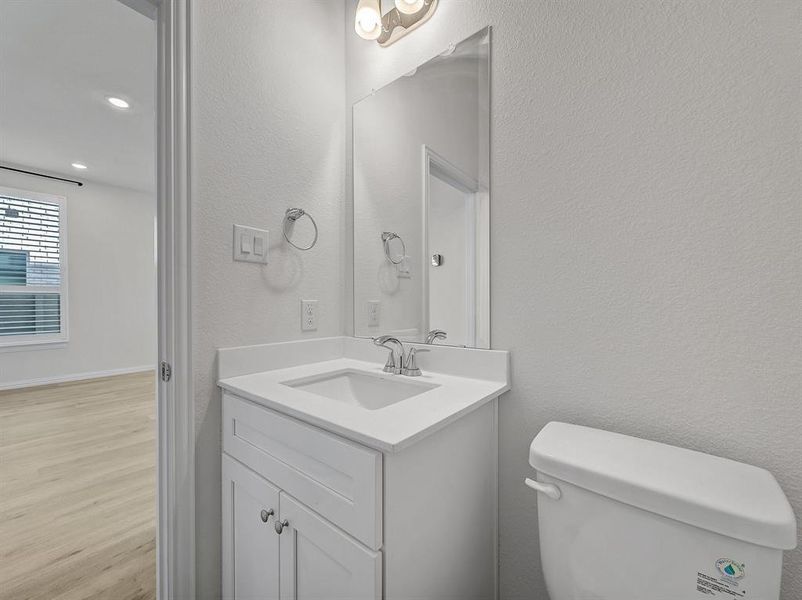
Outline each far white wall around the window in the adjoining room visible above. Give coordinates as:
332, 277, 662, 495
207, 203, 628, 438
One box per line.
0, 171, 156, 387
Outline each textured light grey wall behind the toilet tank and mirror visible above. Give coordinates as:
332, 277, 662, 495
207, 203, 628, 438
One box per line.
345, 0, 802, 600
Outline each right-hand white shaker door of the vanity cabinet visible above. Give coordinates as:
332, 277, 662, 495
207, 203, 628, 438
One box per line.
279, 492, 382, 600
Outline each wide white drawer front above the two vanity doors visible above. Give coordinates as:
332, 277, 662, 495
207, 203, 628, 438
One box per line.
223, 392, 382, 550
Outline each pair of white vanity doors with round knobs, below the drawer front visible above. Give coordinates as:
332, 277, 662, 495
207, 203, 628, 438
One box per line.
223, 455, 381, 600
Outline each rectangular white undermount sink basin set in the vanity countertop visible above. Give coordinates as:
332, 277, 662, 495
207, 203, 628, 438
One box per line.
281, 369, 437, 410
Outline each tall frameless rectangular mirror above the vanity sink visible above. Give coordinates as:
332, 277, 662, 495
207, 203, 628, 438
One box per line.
353, 28, 490, 348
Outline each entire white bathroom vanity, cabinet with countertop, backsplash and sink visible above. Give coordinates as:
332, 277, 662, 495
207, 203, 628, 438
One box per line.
218, 337, 509, 600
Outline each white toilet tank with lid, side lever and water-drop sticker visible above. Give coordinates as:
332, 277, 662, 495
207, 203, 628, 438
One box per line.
528, 423, 797, 600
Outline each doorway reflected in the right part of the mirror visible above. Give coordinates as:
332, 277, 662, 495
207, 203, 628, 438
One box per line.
423, 147, 490, 347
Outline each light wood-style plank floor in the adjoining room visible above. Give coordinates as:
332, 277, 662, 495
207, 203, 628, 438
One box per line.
0, 372, 156, 600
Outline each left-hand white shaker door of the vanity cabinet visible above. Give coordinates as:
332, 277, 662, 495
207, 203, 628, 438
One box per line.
223, 454, 279, 600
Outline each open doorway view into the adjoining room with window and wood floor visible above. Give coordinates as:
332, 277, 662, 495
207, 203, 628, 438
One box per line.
0, 0, 159, 599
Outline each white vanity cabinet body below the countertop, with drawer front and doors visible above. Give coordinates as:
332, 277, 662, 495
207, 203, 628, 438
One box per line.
222, 392, 497, 600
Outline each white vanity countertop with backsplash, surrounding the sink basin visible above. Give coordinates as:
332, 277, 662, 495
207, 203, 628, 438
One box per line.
218, 338, 510, 452
